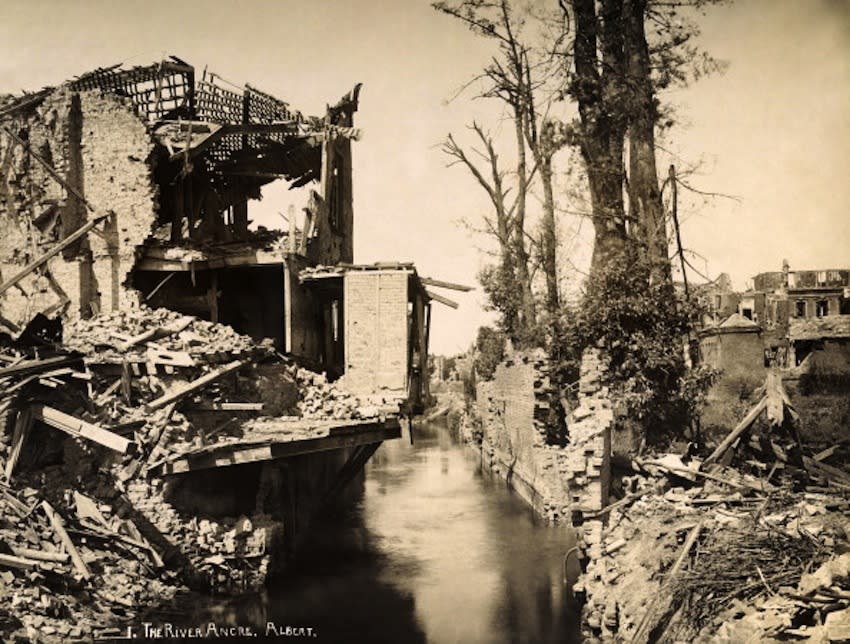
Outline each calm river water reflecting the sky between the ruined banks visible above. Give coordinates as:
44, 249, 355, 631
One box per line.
167, 424, 580, 644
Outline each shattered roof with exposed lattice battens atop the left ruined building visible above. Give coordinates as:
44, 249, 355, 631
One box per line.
0, 56, 360, 187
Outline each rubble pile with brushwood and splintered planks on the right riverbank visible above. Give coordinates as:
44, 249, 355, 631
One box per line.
574, 370, 850, 643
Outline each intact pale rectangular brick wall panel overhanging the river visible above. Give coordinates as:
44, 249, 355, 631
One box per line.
343, 271, 409, 394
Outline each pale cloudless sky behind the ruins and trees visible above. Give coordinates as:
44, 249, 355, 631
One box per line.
0, 0, 850, 354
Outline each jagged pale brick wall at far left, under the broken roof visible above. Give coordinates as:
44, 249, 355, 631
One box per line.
0, 88, 157, 326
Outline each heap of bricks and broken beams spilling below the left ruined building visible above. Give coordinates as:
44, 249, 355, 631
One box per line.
0, 308, 386, 642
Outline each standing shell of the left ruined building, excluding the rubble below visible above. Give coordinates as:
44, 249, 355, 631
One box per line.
0, 57, 438, 406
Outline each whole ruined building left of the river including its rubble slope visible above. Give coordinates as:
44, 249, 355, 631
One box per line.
0, 58, 468, 641
